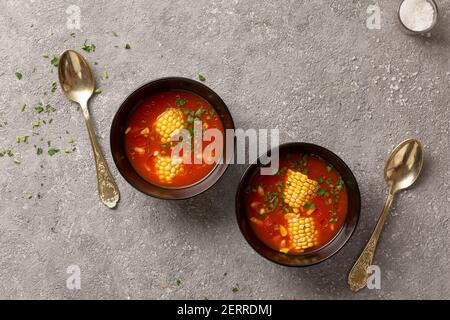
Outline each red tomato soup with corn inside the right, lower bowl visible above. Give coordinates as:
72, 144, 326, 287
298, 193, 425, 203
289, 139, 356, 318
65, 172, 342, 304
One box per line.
245, 154, 348, 254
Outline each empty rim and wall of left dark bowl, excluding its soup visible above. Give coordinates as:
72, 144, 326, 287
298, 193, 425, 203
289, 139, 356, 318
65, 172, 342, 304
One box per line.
110, 77, 234, 200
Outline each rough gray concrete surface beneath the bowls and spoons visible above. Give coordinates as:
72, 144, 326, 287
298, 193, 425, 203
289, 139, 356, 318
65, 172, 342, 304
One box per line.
0, 0, 450, 299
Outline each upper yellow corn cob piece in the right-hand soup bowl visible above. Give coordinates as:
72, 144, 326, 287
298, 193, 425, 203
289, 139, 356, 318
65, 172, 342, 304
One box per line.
283, 169, 319, 208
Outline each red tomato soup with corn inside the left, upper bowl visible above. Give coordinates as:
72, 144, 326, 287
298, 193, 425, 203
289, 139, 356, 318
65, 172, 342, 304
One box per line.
125, 90, 224, 187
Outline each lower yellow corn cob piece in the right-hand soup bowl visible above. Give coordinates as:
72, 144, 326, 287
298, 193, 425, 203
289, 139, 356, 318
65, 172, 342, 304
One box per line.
284, 213, 319, 251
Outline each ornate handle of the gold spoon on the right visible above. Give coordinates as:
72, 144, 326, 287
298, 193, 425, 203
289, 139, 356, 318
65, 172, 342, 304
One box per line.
348, 190, 394, 292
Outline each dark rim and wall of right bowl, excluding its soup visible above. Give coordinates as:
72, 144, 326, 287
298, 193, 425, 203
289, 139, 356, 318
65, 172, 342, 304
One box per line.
236, 143, 361, 267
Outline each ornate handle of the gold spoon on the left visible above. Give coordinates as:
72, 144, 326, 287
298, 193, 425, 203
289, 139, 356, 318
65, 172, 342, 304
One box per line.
81, 102, 120, 209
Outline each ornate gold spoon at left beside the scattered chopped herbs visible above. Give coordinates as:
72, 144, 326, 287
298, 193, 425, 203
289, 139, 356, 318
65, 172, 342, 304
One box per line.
58, 50, 120, 209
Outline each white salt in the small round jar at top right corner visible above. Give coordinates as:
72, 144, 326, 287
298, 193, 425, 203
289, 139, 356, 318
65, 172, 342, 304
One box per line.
400, 0, 436, 32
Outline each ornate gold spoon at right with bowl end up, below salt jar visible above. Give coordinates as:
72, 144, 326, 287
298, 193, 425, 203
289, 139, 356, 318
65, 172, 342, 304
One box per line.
348, 139, 423, 292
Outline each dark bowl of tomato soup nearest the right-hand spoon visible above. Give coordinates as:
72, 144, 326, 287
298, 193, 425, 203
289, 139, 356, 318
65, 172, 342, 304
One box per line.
236, 143, 361, 267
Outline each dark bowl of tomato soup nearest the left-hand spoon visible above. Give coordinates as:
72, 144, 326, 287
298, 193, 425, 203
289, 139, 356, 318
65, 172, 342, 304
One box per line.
111, 77, 234, 199
